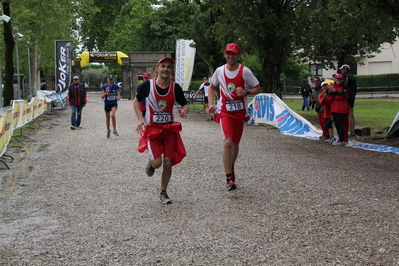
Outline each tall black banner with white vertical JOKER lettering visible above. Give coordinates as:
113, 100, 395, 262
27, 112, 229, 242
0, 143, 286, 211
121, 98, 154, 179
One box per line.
55, 41, 72, 97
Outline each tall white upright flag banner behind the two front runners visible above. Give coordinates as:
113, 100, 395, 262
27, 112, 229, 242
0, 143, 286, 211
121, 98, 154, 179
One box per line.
175, 39, 196, 91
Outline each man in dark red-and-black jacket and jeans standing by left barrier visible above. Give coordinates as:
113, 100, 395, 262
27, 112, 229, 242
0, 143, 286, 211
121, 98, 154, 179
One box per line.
68, 76, 87, 130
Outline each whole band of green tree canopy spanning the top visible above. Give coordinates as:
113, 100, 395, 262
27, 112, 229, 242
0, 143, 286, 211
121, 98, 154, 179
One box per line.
0, 0, 399, 101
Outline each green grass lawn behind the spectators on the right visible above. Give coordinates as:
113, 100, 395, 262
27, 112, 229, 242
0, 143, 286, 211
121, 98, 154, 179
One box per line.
284, 99, 399, 136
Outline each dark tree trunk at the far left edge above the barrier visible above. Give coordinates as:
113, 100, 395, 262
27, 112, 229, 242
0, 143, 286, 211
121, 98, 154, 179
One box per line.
3, 2, 15, 106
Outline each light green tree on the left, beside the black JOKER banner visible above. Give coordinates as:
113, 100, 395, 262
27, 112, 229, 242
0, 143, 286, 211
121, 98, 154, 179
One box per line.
11, 0, 80, 96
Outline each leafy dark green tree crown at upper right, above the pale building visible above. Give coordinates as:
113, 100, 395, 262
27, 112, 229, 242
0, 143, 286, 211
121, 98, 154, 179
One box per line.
295, 0, 398, 69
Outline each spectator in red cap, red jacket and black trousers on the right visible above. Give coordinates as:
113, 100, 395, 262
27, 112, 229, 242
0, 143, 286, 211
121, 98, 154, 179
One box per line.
328, 74, 349, 146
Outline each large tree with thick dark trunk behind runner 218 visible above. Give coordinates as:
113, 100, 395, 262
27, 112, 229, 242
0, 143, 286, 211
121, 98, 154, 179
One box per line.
212, 0, 299, 96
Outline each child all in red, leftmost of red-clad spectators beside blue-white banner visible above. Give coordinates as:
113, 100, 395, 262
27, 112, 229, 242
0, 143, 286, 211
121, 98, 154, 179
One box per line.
318, 81, 335, 143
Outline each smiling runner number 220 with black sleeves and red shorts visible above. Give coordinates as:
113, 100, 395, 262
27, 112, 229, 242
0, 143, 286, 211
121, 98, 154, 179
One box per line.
133, 57, 190, 204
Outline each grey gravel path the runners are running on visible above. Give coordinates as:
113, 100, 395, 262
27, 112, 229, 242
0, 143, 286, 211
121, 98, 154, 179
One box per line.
0, 98, 399, 265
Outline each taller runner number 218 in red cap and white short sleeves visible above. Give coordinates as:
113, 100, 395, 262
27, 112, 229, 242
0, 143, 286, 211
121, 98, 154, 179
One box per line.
208, 43, 262, 191
